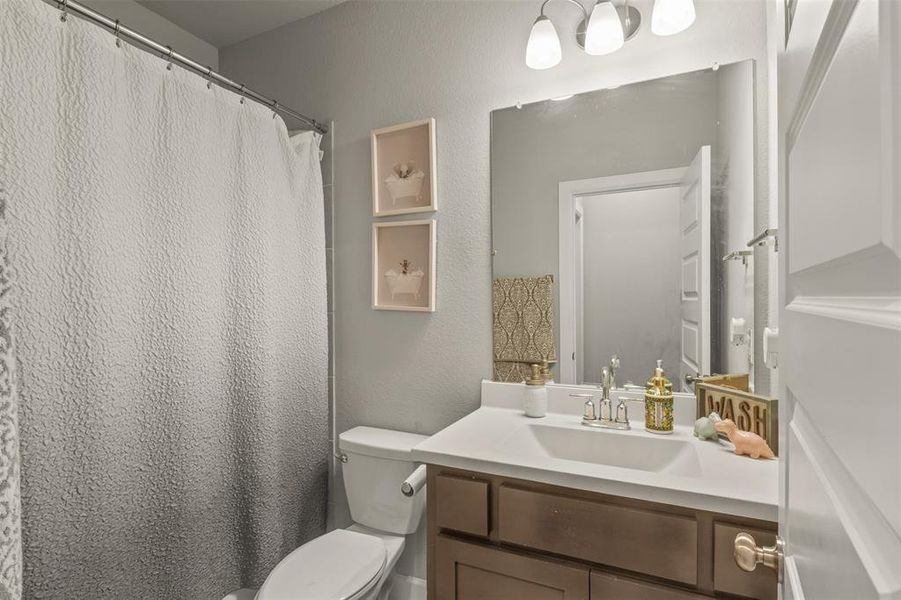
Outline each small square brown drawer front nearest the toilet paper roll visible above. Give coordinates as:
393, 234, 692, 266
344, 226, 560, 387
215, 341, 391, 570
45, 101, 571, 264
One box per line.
435, 474, 489, 537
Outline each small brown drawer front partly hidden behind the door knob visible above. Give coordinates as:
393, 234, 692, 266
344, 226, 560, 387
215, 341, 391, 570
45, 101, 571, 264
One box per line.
713, 521, 778, 600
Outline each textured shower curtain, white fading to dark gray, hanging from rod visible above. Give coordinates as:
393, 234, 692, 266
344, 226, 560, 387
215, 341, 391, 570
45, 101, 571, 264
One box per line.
0, 0, 329, 600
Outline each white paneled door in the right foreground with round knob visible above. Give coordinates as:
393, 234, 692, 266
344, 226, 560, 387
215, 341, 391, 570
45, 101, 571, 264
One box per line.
772, 0, 901, 600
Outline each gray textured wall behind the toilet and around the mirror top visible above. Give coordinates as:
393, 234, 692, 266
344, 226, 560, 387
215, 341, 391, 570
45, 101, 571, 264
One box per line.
220, 0, 766, 575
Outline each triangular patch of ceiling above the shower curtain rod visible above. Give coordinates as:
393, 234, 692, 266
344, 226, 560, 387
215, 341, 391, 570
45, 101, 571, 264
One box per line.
138, 0, 344, 48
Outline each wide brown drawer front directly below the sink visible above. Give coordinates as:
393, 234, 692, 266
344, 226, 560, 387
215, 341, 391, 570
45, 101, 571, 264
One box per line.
498, 485, 698, 585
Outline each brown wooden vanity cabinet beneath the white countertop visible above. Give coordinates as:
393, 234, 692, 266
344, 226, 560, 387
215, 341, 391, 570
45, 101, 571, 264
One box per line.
427, 465, 776, 600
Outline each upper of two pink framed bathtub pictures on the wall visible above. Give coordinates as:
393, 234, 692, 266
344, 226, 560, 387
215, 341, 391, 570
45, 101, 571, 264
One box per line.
372, 119, 438, 217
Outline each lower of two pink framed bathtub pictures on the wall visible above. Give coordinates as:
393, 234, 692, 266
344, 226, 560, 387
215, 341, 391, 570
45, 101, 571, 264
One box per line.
372, 219, 436, 312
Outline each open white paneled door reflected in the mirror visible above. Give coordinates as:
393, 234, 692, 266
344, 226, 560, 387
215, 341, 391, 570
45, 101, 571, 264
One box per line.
684, 146, 710, 392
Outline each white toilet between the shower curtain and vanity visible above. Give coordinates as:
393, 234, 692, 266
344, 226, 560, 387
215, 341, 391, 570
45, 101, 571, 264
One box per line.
256, 427, 426, 600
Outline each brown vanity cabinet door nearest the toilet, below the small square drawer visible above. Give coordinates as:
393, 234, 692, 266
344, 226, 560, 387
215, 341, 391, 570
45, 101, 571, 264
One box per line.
432, 536, 588, 600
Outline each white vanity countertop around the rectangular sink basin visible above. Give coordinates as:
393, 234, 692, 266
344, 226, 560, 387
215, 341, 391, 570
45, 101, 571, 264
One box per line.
413, 382, 779, 521
